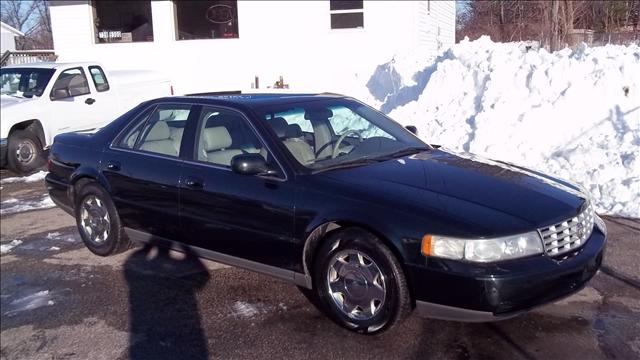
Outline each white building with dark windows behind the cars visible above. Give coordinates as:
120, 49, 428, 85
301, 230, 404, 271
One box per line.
51, 0, 455, 94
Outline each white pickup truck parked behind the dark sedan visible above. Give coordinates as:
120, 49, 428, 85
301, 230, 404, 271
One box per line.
0, 63, 173, 174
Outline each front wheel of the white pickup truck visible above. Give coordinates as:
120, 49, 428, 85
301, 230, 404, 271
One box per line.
7, 128, 45, 175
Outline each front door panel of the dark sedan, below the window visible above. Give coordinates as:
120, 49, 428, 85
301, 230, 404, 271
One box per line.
180, 163, 301, 271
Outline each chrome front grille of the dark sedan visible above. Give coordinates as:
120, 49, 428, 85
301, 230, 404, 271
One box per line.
540, 202, 595, 257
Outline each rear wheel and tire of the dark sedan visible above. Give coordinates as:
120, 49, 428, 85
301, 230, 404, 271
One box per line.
75, 183, 131, 256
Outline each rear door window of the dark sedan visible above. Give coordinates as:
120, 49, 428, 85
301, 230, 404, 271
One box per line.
118, 104, 191, 157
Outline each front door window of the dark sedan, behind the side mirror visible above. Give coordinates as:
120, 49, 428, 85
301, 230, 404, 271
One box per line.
196, 107, 267, 166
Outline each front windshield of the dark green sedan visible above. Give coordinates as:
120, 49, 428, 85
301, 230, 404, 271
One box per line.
259, 98, 431, 171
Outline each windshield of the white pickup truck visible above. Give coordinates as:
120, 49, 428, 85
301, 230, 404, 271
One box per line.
0, 68, 55, 97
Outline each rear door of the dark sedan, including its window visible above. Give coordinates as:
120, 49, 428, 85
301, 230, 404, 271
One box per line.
101, 104, 193, 240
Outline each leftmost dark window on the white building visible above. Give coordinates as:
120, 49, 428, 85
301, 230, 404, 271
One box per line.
92, 0, 153, 43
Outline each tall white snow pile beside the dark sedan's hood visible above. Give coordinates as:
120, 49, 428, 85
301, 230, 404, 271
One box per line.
363, 37, 640, 217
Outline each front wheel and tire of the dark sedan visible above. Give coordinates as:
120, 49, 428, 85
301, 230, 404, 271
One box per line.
310, 228, 412, 334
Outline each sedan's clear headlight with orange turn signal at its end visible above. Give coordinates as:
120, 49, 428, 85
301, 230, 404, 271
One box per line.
422, 231, 543, 262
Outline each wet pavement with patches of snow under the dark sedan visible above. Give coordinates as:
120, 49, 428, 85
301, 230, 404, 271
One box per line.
0, 170, 640, 360
